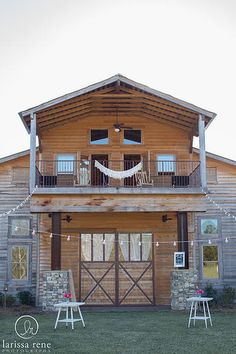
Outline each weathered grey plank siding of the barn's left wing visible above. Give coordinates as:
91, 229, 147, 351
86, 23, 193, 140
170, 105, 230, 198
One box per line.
0, 156, 37, 293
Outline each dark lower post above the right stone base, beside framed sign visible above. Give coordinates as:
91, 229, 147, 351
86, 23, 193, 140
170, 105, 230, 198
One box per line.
177, 211, 189, 269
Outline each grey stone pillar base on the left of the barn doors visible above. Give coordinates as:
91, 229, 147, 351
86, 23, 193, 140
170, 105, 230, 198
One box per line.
40, 270, 69, 311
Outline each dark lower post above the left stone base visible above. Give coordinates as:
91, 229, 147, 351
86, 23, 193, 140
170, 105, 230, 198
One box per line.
51, 213, 61, 270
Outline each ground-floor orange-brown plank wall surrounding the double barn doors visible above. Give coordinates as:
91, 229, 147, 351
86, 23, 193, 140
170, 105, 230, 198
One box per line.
40, 212, 194, 304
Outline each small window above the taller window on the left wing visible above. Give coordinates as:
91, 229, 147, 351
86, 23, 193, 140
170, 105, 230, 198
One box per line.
9, 216, 30, 237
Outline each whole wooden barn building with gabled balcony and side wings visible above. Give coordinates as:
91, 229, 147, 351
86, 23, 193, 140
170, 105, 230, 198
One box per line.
0, 74, 236, 308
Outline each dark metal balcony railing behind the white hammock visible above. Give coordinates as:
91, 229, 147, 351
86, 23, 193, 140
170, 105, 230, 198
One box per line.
36, 160, 200, 188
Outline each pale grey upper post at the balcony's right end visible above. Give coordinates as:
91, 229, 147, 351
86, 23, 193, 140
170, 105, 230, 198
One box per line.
198, 114, 207, 189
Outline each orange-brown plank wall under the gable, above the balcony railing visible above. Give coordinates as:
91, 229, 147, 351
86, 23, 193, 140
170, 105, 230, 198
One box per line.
40, 114, 190, 160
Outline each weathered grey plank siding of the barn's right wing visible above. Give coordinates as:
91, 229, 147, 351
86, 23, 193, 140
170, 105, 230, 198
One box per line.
195, 154, 236, 287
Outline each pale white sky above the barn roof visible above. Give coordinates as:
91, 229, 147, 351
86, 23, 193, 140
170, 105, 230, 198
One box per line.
0, 0, 236, 160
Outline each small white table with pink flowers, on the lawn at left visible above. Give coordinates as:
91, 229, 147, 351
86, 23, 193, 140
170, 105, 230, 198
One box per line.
54, 301, 85, 329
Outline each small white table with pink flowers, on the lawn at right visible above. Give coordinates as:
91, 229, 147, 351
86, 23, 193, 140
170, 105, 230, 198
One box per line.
187, 296, 213, 328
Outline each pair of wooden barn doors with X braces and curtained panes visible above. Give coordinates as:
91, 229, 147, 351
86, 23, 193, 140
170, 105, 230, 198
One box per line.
80, 233, 154, 306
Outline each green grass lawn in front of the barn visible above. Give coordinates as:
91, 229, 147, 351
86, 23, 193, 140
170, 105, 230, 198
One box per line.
0, 310, 236, 354
